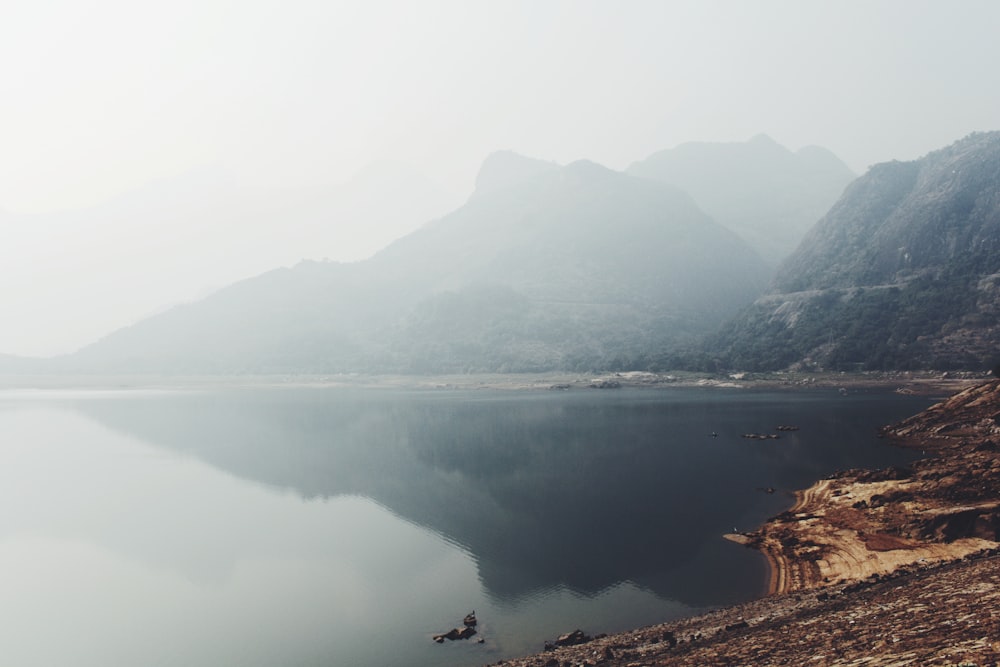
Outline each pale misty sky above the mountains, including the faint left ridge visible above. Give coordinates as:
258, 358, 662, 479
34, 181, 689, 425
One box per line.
0, 0, 1000, 355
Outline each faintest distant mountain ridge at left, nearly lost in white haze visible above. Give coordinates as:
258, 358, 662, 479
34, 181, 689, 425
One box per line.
0, 162, 464, 355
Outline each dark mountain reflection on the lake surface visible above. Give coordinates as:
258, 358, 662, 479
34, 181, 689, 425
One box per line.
75, 389, 925, 607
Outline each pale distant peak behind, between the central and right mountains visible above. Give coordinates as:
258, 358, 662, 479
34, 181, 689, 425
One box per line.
628, 134, 855, 266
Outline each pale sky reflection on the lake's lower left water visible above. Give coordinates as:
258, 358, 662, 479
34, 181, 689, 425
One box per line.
0, 403, 496, 667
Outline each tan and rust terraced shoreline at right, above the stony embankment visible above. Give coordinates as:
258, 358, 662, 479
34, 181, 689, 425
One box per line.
743, 381, 1000, 594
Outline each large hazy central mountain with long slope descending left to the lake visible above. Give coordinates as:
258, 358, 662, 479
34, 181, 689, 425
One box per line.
60, 156, 768, 373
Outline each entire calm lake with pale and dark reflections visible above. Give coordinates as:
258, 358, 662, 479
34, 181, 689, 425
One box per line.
0, 389, 930, 667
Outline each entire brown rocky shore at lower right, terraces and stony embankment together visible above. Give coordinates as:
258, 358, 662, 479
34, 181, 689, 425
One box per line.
484, 381, 1000, 667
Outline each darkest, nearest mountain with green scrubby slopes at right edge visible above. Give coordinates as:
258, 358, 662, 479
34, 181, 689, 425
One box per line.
715, 132, 1000, 369
